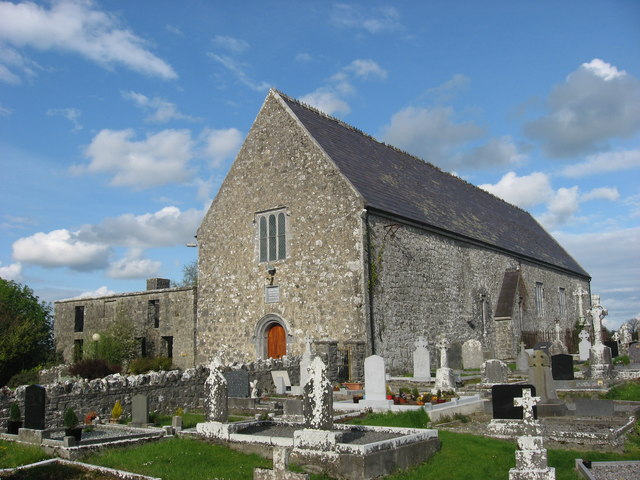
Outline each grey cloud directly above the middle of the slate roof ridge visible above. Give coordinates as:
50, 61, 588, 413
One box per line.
382, 107, 484, 168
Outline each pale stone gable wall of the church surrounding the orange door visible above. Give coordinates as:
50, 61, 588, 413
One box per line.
197, 92, 366, 362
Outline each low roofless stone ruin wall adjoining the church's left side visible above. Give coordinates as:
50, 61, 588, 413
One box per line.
54, 287, 196, 369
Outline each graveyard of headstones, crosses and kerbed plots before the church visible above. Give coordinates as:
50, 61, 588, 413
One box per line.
0, 316, 640, 480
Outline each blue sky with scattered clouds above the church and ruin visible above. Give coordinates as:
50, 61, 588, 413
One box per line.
0, 0, 640, 328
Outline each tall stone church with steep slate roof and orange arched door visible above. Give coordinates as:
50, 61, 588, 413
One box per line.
56, 90, 590, 378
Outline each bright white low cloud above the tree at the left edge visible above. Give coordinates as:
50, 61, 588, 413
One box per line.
13, 229, 110, 271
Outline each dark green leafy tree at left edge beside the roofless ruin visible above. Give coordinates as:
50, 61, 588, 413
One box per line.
0, 278, 53, 385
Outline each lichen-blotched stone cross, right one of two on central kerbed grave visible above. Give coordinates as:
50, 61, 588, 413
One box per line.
302, 357, 332, 430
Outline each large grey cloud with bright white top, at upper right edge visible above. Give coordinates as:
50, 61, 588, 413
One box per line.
524, 58, 640, 157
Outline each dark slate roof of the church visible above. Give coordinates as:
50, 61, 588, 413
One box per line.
276, 92, 589, 277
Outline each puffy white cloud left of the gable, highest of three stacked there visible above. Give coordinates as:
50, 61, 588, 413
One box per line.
74, 129, 193, 189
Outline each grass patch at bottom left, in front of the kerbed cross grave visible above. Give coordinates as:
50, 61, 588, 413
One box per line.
84, 438, 271, 480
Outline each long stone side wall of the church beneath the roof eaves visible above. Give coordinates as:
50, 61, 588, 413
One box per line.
369, 215, 589, 374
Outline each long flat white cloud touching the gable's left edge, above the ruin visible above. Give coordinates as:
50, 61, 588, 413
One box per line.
78, 206, 204, 248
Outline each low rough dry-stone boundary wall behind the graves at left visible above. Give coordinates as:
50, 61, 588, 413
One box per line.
0, 356, 300, 429
